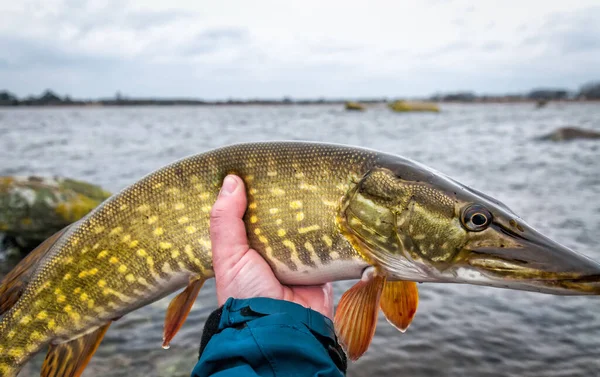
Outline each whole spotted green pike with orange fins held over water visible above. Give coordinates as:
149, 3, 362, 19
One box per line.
0, 142, 600, 377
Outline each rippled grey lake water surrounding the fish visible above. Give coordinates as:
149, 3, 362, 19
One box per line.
0, 104, 600, 377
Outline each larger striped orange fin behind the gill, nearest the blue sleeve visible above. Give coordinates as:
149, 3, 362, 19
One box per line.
334, 267, 385, 360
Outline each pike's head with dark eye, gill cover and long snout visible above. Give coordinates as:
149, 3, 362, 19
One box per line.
340, 159, 600, 295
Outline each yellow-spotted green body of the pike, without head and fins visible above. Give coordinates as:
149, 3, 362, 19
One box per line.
0, 142, 378, 376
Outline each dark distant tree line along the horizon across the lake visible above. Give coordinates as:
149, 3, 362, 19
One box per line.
0, 81, 600, 106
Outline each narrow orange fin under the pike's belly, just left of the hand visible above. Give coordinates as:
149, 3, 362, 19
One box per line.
163, 279, 204, 349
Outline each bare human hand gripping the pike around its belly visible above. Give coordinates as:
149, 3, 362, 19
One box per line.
210, 175, 333, 318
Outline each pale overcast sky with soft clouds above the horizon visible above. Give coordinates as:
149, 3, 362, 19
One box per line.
0, 0, 600, 99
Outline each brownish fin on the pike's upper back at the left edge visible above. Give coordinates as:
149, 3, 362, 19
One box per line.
0, 226, 69, 314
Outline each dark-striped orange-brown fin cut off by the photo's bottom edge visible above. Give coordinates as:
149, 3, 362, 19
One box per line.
40, 322, 110, 377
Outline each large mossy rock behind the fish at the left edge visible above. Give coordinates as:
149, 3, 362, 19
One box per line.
0, 176, 111, 252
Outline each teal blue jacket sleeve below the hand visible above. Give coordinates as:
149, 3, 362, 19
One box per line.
192, 297, 346, 377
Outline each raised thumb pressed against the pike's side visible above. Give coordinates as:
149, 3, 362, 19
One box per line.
210, 175, 249, 279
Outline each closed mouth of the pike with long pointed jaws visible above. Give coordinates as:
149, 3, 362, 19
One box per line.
444, 224, 600, 295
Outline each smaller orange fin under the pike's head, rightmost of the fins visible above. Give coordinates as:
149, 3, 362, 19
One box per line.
379, 280, 419, 332
